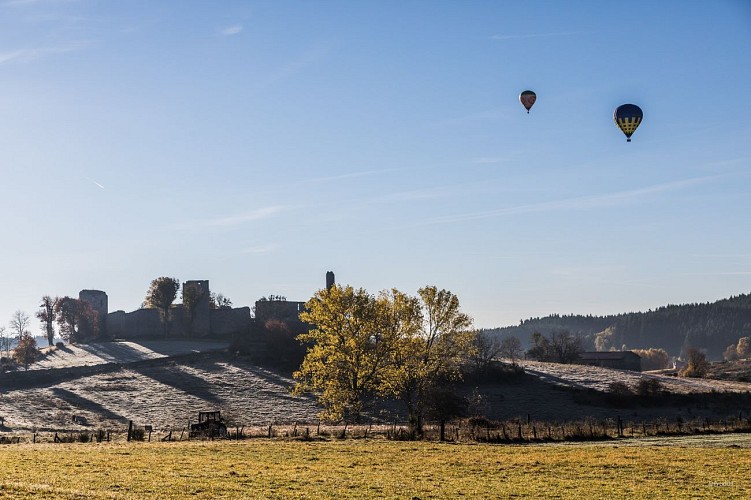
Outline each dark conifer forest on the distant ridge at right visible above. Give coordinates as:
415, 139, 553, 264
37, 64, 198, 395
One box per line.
485, 295, 751, 359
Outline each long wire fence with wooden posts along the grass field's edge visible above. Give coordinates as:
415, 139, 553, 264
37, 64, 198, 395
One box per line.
5, 416, 751, 444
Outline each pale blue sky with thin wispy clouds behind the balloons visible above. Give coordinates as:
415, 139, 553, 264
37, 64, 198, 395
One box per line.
0, 0, 751, 333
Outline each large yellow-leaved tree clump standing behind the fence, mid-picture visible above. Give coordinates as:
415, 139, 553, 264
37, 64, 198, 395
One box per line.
293, 285, 474, 428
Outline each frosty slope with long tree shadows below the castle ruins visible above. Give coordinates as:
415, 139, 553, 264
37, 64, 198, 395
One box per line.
0, 354, 319, 432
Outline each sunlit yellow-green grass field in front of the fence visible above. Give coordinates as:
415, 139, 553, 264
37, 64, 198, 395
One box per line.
0, 434, 751, 499
